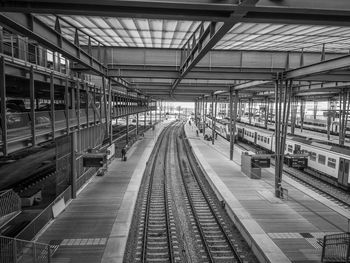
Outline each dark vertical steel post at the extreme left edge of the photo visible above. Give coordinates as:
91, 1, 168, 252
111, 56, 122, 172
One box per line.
0, 57, 8, 156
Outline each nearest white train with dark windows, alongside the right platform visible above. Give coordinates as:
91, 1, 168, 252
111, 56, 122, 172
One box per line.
207, 118, 350, 189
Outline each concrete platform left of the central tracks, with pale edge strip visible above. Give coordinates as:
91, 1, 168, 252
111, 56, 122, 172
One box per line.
38, 122, 168, 263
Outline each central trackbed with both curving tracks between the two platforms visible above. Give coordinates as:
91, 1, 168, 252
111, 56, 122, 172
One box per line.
124, 122, 257, 263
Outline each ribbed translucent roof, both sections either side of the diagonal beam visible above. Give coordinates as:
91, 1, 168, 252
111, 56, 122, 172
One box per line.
36, 15, 350, 53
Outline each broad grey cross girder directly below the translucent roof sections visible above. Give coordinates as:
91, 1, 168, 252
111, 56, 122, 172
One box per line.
104, 47, 350, 81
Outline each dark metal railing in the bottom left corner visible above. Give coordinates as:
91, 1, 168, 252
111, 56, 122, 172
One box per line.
0, 236, 51, 263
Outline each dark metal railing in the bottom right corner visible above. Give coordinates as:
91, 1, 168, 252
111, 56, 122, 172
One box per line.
321, 233, 350, 263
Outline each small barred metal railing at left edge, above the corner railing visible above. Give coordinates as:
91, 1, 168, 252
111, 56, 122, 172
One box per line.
0, 189, 21, 220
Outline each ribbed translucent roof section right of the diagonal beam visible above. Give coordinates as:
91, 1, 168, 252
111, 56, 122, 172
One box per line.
214, 23, 350, 53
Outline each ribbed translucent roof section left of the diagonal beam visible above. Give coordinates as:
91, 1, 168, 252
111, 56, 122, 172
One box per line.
36, 15, 204, 48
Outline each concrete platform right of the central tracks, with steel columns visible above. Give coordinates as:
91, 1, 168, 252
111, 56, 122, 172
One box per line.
185, 124, 350, 263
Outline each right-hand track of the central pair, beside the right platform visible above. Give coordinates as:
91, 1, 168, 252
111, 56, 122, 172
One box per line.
177, 128, 243, 262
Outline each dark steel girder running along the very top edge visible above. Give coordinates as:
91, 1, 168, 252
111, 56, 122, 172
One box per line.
0, 0, 350, 25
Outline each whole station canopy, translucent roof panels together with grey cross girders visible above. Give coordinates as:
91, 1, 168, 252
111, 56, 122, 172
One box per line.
28, 8, 350, 100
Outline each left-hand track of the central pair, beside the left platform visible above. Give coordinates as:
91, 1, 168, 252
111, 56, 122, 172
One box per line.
136, 122, 181, 262
